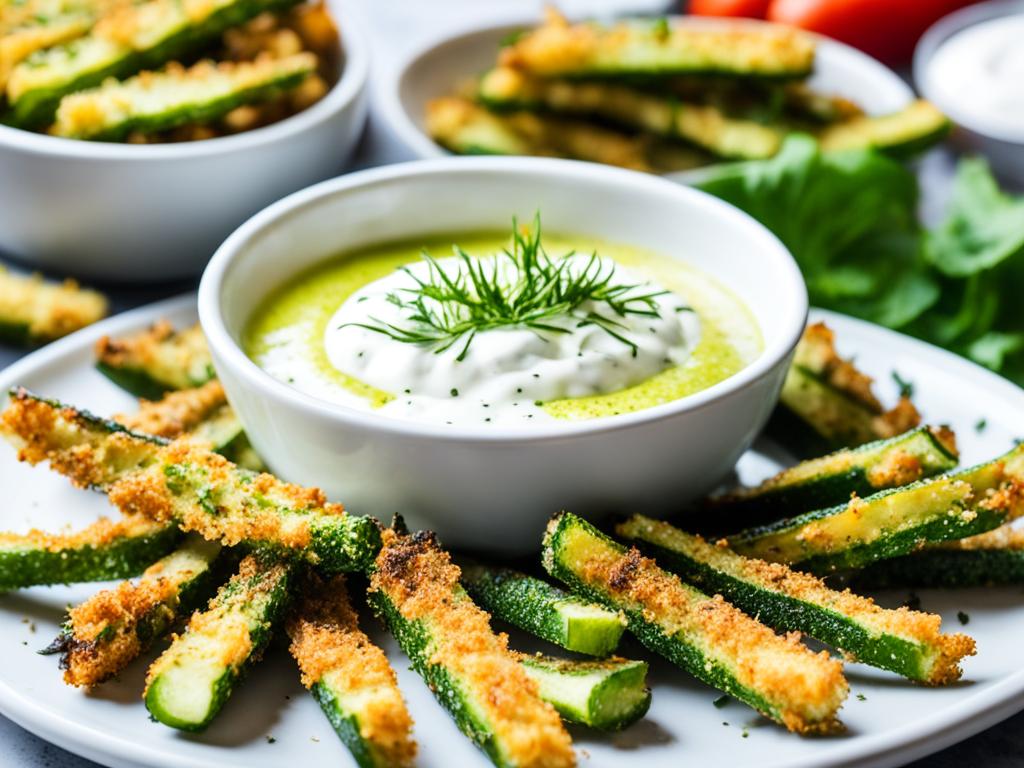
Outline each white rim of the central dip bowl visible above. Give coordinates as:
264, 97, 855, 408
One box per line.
199, 157, 809, 443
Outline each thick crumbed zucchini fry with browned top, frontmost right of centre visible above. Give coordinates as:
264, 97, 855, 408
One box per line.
544, 513, 849, 733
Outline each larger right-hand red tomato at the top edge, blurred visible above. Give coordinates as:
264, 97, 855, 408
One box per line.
768, 0, 977, 63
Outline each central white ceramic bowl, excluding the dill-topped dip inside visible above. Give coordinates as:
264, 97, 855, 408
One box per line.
199, 158, 807, 553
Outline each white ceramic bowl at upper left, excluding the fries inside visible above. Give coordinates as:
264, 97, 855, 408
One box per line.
0, 0, 370, 282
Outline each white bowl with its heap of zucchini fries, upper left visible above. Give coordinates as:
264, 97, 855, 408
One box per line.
0, 0, 369, 282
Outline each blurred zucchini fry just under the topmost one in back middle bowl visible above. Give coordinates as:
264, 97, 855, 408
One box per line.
478, 67, 781, 160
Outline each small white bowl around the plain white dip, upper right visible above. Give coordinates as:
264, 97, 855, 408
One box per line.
913, 0, 1024, 188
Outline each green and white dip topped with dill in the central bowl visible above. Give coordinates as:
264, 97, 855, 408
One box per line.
244, 228, 762, 428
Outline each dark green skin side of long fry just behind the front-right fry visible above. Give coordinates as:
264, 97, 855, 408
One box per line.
617, 521, 929, 681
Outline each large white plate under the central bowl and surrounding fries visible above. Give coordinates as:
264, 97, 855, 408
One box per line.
0, 297, 1024, 768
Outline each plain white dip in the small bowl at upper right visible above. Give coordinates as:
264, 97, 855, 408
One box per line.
926, 13, 1024, 135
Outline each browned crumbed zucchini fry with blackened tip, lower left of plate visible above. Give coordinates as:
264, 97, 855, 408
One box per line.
47, 535, 221, 687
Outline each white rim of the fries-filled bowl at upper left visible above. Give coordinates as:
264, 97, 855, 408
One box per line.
0, 0, 370, 163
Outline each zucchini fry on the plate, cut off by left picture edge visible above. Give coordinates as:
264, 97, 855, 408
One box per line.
0, 515, 181, 590
